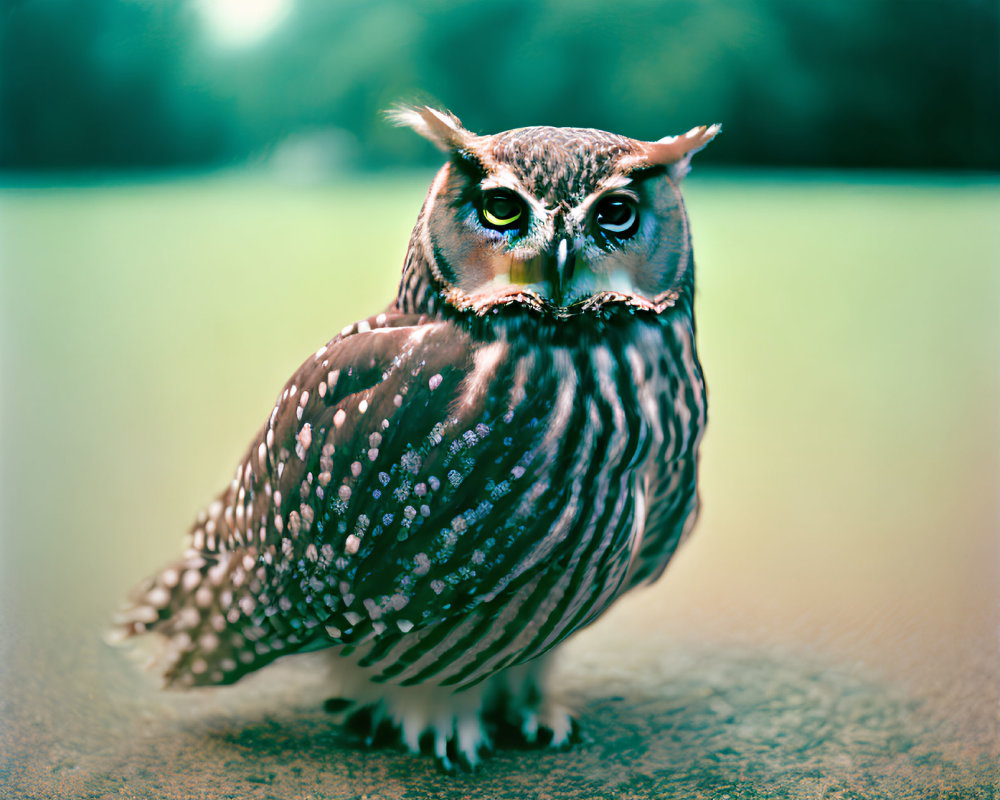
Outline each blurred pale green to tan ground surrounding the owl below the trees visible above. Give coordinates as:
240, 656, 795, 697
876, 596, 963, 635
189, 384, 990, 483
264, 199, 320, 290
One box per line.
0, 173, 1000, 798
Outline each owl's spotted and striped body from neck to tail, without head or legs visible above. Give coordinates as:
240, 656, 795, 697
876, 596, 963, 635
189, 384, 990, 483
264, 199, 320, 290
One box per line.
121, 307, 705, 689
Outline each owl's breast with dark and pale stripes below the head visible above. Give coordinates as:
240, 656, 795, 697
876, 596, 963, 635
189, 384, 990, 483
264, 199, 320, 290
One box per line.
320, 310, 704, 686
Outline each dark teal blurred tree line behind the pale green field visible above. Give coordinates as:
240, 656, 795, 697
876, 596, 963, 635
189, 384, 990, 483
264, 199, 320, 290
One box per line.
0, 0, 1000, 170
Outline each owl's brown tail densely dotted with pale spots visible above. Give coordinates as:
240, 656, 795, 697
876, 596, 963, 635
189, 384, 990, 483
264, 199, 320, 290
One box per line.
108, 550, 302, 687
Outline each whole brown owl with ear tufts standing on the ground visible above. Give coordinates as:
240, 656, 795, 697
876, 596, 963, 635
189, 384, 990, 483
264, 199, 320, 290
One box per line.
117, 107, 720, 769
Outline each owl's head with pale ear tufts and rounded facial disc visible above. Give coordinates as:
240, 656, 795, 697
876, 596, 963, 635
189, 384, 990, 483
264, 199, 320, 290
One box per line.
390, 106, 721, 319
